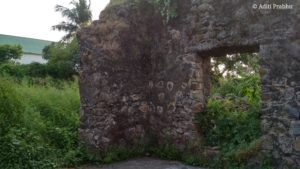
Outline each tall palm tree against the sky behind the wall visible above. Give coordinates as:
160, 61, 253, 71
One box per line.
52, 0, 92, 40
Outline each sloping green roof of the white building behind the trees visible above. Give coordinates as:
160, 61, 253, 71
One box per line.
0, 34, 52, 55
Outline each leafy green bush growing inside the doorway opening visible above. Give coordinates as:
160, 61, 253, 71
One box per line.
197, 75, 261, 167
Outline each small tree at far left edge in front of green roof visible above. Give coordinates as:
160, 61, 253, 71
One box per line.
0, 45, 23, 63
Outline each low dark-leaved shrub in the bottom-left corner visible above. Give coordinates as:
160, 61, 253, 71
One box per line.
0, 127, 57, 169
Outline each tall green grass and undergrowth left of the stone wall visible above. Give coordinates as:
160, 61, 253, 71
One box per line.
0, 78, 83, 169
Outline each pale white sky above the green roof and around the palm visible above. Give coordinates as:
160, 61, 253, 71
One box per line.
0, 0, 109, 41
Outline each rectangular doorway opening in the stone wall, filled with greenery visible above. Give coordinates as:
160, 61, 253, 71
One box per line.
197, 53, 261, 167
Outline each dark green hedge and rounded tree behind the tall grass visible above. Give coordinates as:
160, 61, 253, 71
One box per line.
0, 39, 80, 79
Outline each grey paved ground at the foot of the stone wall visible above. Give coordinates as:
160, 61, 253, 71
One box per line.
76, 158, 203, 169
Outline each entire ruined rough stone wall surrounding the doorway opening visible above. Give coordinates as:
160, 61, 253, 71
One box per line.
79, 0, 300, 168
